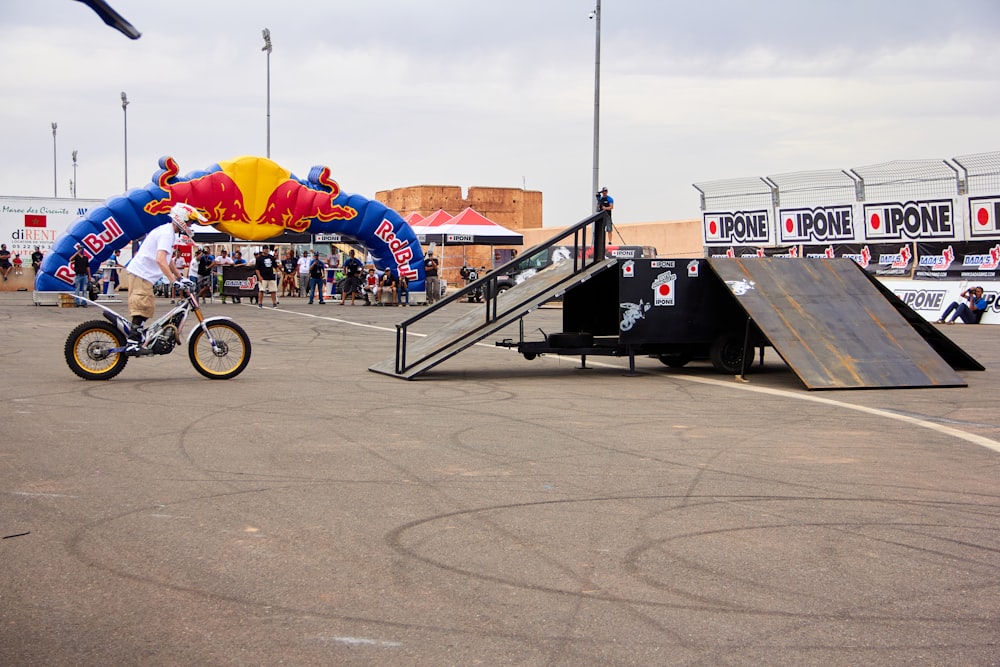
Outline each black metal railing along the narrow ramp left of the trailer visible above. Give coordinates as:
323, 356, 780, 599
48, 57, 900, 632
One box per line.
395, 211, 611, 375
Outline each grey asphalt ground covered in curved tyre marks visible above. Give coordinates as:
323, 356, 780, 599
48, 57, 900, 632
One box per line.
0, 293, 1000, 666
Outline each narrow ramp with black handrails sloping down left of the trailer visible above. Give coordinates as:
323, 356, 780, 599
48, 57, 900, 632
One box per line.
368, 214, 618, 380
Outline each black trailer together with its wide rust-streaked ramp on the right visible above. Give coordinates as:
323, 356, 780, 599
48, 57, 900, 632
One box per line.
496, 258, 983, 389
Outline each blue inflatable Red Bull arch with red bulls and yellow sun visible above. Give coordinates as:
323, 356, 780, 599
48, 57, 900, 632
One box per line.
35, 156, 424, 292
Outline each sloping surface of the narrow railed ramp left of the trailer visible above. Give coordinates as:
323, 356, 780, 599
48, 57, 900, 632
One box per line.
368, 259, 618, 380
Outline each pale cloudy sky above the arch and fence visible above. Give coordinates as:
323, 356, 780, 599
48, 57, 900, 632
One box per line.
0, 0, 1000, 227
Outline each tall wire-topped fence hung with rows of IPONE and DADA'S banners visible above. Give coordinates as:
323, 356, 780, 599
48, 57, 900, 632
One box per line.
694, 152, 1000, 280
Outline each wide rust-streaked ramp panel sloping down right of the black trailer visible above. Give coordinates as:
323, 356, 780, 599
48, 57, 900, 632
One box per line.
708, 258, 966, 389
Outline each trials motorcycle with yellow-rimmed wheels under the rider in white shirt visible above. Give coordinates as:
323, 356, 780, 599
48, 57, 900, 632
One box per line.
65, 284, 250, 380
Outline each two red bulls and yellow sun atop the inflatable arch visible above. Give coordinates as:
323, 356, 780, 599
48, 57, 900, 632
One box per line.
144, 157, 358, 241
